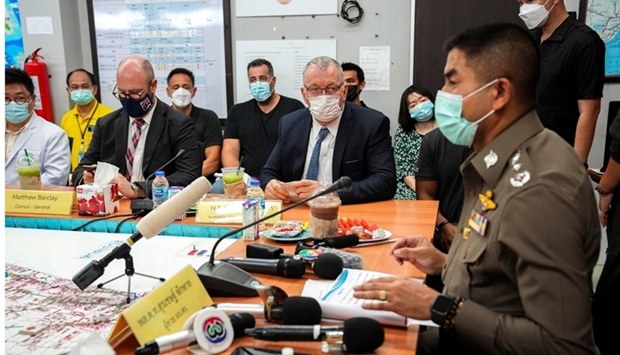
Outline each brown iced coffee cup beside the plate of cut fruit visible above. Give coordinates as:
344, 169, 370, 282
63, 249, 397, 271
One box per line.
308, 189, 341, 239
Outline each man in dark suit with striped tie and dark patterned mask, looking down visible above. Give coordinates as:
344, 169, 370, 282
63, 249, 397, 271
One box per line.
72, 55, 201, 198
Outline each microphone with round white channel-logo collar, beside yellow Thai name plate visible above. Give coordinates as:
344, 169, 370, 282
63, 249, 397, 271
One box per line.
134, 307, 256, 355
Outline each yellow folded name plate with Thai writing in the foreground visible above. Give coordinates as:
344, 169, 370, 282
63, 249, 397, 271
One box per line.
108, 265, 213, 346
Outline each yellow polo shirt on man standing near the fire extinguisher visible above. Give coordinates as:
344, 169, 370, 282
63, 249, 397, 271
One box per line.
60, 102, 113, 171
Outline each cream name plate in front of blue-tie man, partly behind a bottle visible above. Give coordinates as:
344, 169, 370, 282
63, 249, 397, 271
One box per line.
196, 199, 282, 225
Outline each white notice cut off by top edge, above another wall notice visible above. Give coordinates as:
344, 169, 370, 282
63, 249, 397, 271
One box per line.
237, 0, 338, 17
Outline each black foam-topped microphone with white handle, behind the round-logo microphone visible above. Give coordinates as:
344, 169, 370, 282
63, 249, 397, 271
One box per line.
216, 296, 322, 325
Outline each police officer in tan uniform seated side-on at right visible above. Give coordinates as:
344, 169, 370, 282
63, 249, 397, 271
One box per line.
355, 24, 600, 355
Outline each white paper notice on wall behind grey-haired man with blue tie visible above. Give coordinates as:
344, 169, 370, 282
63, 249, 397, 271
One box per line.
235, 39, 336, 102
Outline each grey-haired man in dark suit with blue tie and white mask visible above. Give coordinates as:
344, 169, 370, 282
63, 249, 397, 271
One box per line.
260, 57, 396, 204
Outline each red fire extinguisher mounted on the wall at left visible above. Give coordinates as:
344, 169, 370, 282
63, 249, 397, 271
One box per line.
24, 48, 55, 123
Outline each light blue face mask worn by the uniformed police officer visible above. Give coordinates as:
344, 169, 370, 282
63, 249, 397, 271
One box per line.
435, 79, 497, 146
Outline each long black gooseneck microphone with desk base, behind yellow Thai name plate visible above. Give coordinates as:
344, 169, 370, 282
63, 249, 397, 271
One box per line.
198, 176, 351, 297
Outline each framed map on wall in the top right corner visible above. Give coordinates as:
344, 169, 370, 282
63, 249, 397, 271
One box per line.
581, 0, 620, 82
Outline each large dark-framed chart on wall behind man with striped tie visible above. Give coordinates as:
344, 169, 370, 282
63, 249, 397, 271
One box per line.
88, 0, 233, 117
